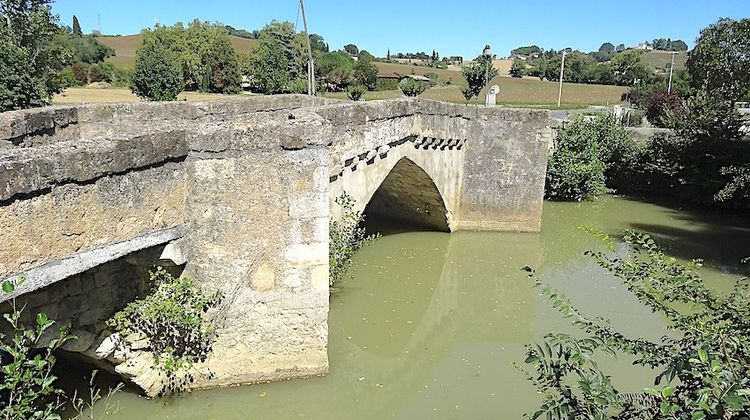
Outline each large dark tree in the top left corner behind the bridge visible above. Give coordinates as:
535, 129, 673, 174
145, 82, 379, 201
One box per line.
0, 0, 71, 111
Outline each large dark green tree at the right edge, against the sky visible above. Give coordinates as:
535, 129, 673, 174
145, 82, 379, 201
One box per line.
687, 19, 750, 101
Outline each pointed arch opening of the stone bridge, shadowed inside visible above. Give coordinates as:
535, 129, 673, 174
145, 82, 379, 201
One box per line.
363, 158, 450, 233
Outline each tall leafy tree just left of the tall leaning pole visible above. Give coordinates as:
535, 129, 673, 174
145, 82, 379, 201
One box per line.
251, 21, 301, 95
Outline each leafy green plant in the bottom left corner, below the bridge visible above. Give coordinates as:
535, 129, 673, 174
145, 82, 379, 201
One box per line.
0, 279, 75, 420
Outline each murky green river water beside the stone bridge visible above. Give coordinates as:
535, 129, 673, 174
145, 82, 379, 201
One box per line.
85, 197, 750, 420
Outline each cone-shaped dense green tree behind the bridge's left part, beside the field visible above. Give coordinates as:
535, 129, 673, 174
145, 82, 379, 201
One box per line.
130, 31, 184, 101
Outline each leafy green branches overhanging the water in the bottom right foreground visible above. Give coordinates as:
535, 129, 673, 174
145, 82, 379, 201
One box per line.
525, 232, 750, 420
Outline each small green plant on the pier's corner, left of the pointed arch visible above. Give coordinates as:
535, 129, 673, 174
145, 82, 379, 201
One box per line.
328, 193, 378, 287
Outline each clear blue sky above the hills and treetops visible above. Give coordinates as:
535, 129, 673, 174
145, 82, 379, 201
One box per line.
53, 0, 750, 57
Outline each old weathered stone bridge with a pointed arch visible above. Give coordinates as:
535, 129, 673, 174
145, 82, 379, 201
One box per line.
0, 95, 551, 389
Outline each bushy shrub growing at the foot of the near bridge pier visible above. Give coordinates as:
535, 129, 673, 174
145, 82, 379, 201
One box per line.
107, 267, 222, 394
